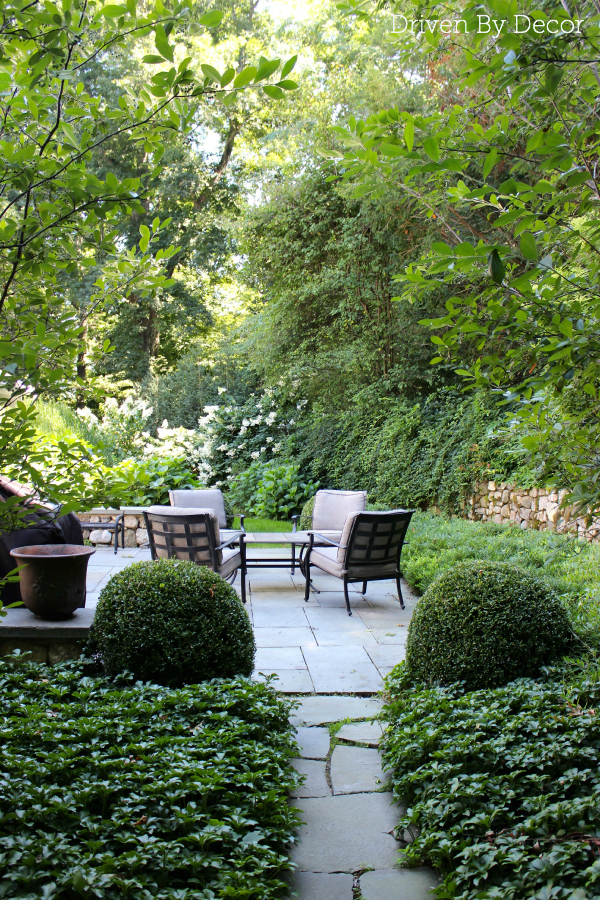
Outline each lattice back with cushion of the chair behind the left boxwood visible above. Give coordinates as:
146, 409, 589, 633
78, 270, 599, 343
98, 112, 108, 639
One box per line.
144, 506, 222, 571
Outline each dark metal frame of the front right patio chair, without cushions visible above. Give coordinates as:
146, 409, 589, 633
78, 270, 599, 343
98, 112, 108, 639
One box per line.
304, 509, 414, 616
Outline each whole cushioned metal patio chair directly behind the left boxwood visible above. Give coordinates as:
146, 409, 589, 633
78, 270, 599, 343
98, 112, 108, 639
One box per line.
144, 506, 246, 603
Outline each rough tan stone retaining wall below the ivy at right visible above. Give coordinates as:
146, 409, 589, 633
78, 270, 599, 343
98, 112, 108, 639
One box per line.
450, 481, 600, 541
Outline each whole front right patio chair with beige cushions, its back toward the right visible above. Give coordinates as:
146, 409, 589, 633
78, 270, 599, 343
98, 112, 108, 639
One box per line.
304, 509, 414, 616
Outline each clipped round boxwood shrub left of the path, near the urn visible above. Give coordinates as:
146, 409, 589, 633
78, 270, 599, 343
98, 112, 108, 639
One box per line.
89, 560, 256, 687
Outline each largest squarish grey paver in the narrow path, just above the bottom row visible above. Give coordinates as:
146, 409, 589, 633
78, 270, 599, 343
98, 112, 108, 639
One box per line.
292, 794, 400, 872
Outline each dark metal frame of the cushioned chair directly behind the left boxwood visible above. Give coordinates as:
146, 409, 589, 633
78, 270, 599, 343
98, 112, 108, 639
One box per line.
144, 507, 246, 603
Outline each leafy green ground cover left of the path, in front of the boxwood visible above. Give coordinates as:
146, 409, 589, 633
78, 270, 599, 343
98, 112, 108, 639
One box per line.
0, 660, 297, 900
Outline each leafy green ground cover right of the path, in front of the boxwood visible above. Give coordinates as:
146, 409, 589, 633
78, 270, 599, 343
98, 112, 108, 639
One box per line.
383, 666, 600, 900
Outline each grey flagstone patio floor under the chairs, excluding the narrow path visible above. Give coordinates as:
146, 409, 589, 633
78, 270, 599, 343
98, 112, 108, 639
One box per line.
86, 548, 416, 694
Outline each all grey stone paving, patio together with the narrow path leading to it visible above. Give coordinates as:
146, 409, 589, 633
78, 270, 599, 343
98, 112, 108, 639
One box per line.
87, 550, 437, 900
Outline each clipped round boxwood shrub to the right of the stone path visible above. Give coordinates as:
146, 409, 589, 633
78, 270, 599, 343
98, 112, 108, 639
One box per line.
406, 560, 572, 690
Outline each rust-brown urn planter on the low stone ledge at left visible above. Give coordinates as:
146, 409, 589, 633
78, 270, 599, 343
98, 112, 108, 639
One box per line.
10, 544, 96, 620
